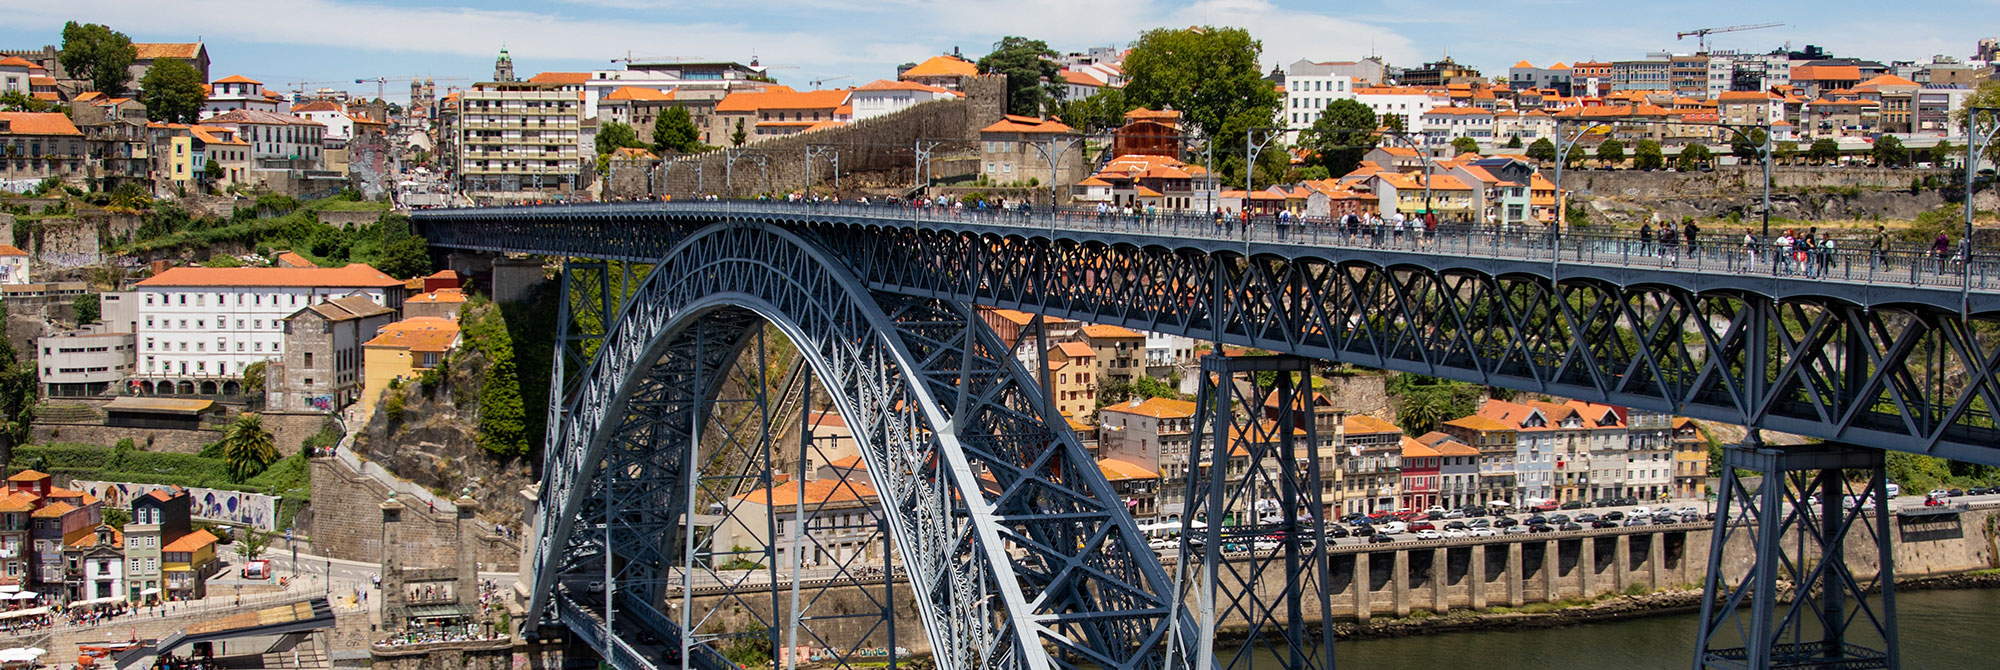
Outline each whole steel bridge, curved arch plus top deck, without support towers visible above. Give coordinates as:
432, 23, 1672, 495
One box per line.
414, 202, 2000, 670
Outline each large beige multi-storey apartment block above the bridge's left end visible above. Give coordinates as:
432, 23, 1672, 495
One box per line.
450, 82, 586, 202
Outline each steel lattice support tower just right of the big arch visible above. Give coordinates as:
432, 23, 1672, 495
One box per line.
1168, 354, 1334, 670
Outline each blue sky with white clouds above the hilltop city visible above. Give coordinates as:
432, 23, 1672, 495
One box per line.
0, 0, 2000, 100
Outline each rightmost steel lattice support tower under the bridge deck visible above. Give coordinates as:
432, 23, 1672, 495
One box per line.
1696, 440, 1900, 668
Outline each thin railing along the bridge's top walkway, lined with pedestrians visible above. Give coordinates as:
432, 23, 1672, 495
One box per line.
450, 200, 2000, 290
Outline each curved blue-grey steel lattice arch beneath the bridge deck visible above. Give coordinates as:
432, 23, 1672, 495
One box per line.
530, 224, 1174, 670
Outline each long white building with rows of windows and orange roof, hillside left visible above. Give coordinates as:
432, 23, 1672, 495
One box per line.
132, 264, 404, 396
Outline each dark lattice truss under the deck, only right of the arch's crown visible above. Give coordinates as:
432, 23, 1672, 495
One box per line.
826, 230, 2000, 464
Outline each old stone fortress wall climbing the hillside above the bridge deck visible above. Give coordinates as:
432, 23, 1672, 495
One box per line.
628, 76, 1006, 198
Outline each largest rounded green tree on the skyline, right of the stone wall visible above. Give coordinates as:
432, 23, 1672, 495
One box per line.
1124, 26, 1278, 142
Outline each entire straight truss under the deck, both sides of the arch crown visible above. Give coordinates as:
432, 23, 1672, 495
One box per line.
416, 202, 2000, 464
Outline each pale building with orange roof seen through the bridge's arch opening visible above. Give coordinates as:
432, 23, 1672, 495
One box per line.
710, 478, 886, 570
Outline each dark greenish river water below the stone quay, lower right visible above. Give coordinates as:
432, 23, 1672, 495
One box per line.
1216, 590, 2000, 670
